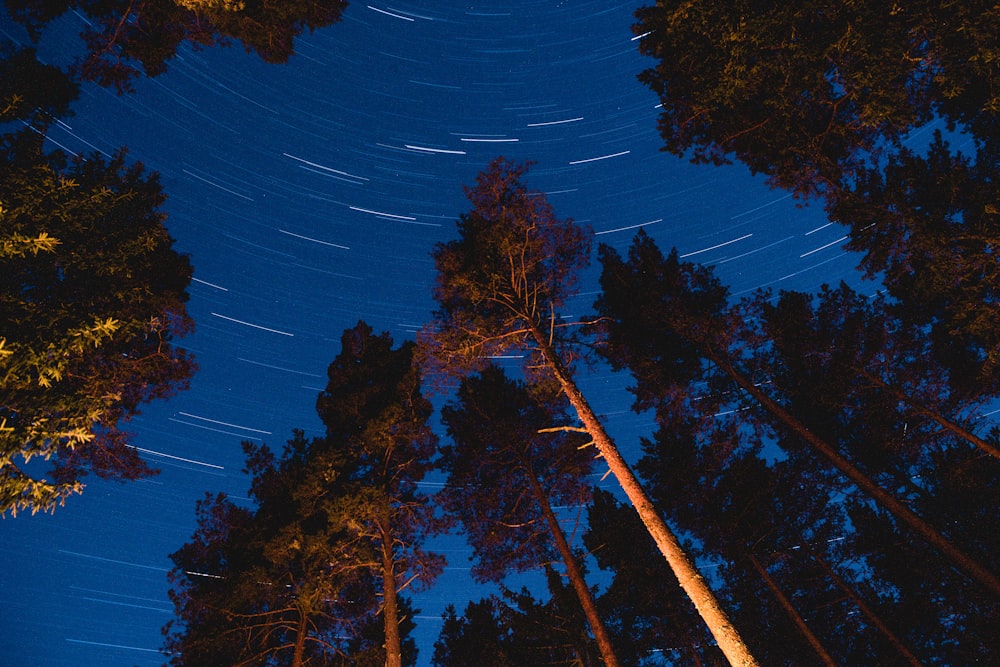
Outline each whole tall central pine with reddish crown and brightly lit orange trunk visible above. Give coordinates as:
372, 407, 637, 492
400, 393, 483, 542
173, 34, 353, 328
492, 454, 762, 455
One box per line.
422, 158, 756, 665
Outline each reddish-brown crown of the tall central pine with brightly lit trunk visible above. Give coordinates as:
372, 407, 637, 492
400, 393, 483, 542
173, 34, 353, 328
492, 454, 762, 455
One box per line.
425, 157, 590, 372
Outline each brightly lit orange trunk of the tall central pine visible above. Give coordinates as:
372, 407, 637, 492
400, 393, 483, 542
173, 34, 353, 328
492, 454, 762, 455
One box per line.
531, 324, 758, 667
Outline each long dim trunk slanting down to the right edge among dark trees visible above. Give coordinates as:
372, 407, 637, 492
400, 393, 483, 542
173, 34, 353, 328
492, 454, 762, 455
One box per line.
707, 350, 1000, 596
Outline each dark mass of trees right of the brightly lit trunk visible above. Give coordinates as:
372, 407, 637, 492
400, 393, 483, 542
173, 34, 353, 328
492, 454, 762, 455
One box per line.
597, 233, 1000, 664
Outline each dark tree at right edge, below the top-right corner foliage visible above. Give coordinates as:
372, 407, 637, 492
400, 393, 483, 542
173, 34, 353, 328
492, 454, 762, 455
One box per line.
830, 132, 1000, 398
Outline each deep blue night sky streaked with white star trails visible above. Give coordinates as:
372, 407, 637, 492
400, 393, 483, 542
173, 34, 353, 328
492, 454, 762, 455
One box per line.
0, 0, 875, 667
